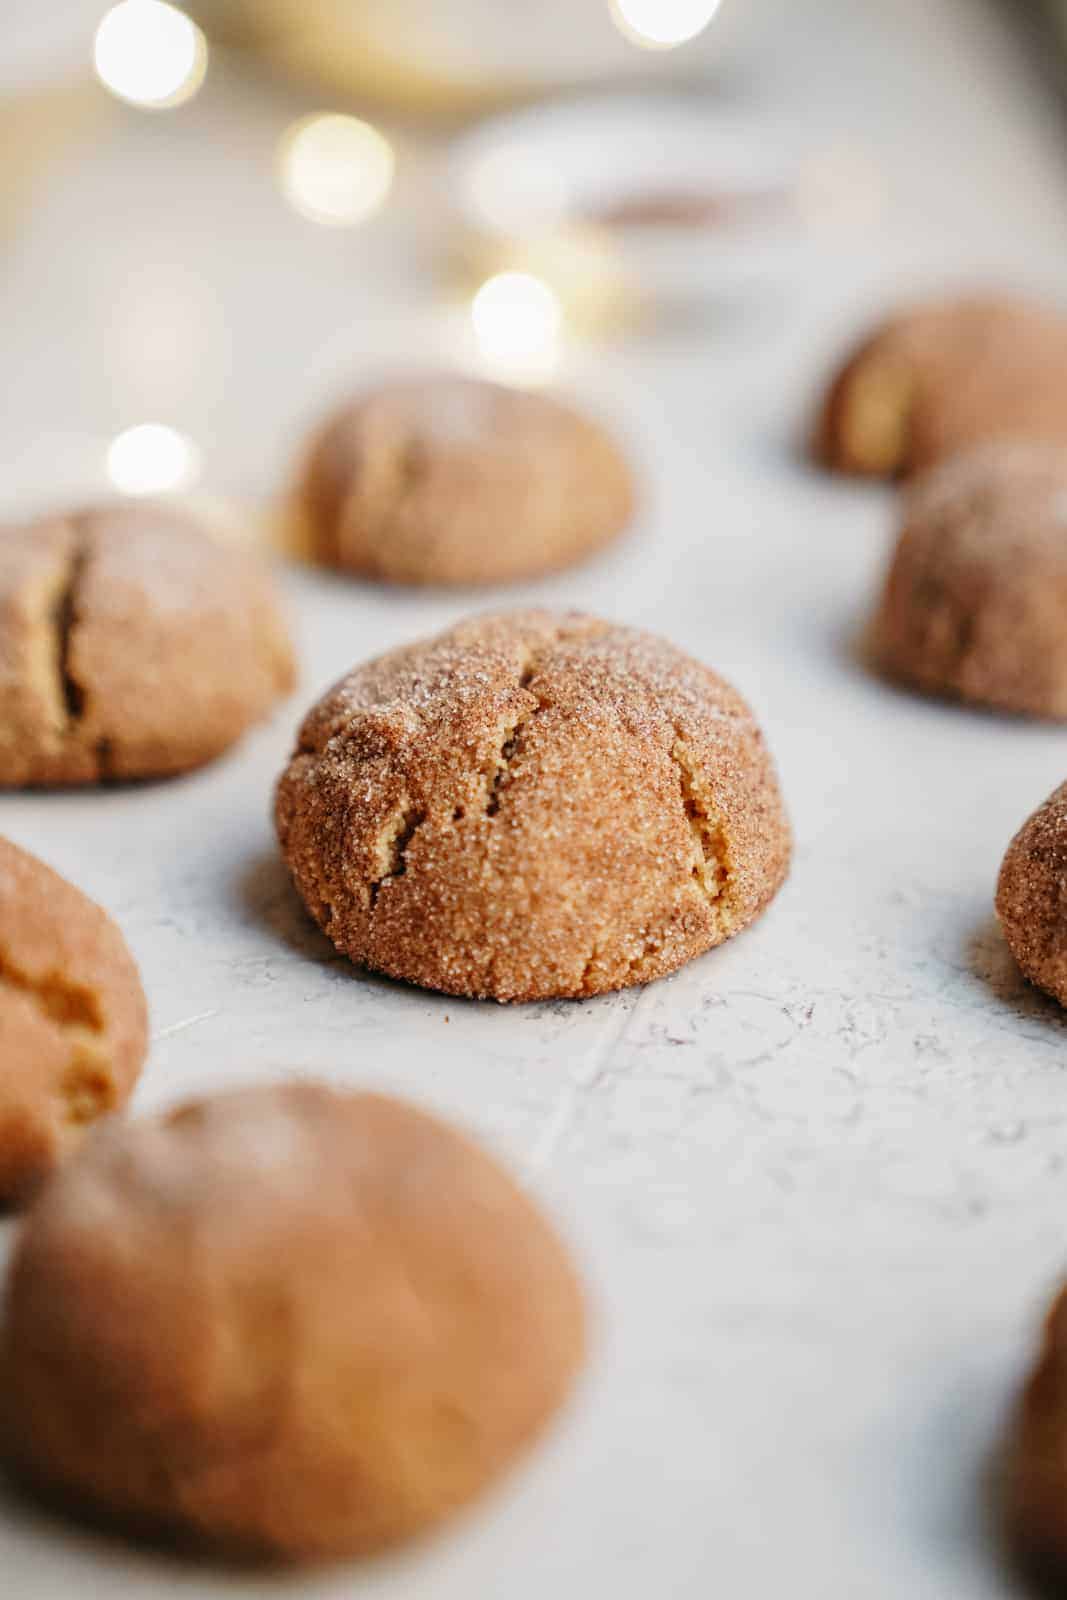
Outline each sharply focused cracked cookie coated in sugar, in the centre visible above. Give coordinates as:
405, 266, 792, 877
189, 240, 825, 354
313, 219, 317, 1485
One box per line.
275, 611, 790, 1000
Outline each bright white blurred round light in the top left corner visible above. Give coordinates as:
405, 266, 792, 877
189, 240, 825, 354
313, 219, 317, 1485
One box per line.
93, 0, 208, 110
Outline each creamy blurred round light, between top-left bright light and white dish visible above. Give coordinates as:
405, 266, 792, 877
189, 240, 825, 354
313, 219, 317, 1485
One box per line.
278, 114, 395, 227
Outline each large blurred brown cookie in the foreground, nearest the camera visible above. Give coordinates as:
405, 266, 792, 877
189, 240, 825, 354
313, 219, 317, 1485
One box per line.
0, 1083, 584, 1560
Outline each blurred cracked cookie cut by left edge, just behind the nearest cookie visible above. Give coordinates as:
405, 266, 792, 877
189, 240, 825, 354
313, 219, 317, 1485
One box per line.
0, 838, 147, 1206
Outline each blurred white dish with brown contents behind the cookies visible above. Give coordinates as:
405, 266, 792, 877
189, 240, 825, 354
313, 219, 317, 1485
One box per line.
443, 93, 854, 298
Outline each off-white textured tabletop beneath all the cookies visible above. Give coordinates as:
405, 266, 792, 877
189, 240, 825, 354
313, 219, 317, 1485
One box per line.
0, 0, 1067, 1600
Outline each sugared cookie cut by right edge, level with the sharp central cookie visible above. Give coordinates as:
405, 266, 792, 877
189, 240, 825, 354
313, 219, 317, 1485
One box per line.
997, 784, 1067, 1005
